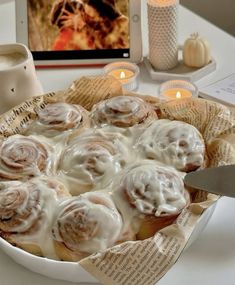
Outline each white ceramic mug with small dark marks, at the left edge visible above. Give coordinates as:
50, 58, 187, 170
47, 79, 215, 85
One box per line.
0, 43, 43, 114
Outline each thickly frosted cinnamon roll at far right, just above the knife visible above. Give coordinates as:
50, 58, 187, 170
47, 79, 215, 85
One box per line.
137, 119, 207, 172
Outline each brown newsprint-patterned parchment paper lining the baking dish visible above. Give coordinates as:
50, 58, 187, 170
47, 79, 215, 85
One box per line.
0, 76, 235, 285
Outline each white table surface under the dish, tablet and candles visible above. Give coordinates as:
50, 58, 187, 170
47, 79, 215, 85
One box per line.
0, 0, 235, 285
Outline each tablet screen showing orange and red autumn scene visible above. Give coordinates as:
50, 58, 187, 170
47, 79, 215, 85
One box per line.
27, 0, 130, 60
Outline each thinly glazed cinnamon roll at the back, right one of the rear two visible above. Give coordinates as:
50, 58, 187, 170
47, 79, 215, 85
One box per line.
91, 96, 157, 128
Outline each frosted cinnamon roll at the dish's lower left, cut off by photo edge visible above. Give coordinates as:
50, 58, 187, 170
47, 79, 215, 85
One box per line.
0, 177, 71, 258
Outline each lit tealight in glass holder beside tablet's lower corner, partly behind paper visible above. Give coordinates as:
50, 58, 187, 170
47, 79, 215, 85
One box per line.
104, 62, 140, 91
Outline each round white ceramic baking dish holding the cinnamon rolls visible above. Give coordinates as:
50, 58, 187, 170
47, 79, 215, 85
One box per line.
0, 203, 216, 283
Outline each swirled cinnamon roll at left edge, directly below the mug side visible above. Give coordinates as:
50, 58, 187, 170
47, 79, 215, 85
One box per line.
0, 135, 67, 180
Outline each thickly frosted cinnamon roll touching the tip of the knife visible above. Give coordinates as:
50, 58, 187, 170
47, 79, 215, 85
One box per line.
113, 160, 190, 239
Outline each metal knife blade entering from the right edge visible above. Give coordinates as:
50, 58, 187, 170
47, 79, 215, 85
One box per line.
184, 164, 235, 198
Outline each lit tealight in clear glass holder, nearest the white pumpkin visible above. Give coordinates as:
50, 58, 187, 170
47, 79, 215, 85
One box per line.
159, 80, 198, 101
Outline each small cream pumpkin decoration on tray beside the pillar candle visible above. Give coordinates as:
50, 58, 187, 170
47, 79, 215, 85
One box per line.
183, 33, 211, 68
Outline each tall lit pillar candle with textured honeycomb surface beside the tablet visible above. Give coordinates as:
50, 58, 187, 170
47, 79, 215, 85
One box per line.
147, 0, 179, 70
